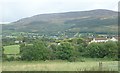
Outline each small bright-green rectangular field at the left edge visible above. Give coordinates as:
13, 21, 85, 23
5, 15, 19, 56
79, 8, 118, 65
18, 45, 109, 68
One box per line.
4, 45, 20, 54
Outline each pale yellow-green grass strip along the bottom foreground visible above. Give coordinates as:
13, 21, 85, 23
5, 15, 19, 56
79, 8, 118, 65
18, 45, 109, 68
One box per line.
2, 61, 118, 71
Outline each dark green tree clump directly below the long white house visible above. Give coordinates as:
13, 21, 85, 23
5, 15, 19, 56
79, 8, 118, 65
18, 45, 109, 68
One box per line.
87, 41, 118, 58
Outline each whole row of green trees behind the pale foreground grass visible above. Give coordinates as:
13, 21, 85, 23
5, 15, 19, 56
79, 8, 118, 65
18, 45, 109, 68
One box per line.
2, 38, 119, 62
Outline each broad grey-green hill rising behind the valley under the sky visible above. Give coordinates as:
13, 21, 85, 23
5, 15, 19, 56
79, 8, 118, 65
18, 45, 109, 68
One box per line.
3, 9, 118, 36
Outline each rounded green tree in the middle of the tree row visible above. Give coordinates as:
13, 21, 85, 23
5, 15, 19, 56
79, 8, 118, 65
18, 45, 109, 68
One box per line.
57, 42, 76, 61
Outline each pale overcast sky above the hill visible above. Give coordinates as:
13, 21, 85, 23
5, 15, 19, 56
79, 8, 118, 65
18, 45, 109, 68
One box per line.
0, 0, 119, 23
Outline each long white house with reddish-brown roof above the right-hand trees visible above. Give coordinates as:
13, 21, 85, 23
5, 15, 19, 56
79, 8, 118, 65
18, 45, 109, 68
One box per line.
89, 37, 118, 44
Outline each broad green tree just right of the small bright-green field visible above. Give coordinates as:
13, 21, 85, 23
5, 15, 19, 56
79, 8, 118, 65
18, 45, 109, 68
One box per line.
21, 40, 49, 61
